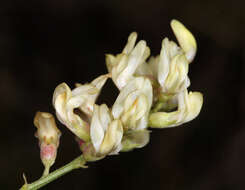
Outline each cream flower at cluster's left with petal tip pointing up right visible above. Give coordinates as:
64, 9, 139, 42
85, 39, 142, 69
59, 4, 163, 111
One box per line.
53, 74, 109, 141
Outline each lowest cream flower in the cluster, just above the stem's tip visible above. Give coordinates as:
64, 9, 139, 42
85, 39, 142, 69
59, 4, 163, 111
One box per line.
90, 104, 123, 156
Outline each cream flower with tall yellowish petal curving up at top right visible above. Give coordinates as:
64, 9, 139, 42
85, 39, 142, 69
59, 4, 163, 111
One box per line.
136, 20, 197, 94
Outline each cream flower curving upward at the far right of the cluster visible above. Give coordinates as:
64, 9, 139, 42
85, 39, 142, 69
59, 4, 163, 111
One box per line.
149, 89, 203, 128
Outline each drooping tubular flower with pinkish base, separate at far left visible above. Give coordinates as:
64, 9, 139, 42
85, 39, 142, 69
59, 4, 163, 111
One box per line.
34, 112, 61, 175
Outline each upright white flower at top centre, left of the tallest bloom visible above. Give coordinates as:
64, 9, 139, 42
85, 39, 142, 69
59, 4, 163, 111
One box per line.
106, 32, 150, 90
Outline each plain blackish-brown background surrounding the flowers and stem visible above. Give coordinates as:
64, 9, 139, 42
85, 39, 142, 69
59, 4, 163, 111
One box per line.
0, 0, 245, 190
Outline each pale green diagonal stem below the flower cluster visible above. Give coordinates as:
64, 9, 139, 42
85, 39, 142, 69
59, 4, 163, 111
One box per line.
20, 155, 86, 190
